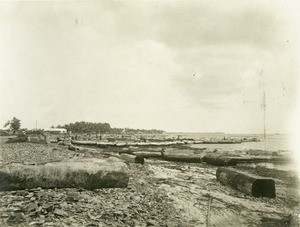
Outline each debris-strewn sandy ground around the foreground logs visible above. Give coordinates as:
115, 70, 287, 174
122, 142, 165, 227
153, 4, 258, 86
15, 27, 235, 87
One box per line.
0, 137, 300, 226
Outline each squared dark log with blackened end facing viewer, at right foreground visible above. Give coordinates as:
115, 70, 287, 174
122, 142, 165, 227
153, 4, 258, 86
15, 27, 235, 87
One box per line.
216, 167, 276, 198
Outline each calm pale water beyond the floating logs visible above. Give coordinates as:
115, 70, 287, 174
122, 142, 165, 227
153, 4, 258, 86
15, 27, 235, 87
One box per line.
166, 133, 292, 151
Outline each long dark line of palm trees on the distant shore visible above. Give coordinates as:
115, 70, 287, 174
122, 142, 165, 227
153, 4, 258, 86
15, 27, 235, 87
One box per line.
57, 121, 164, 134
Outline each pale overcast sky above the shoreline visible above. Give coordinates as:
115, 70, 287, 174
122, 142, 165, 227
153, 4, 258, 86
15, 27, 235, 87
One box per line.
0, 0, 299, 133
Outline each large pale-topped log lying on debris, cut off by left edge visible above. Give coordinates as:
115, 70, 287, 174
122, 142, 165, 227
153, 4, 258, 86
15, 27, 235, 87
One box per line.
0, 157, 129, 191
